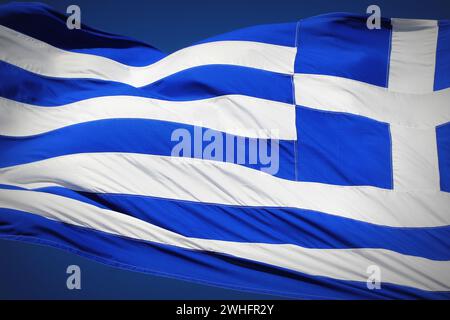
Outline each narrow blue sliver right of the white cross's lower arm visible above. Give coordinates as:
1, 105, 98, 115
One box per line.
436, 123, 450, 192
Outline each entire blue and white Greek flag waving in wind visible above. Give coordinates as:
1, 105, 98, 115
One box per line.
0, 3, 450, 299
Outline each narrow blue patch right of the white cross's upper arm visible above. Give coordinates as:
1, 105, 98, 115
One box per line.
434, 20, 450, 90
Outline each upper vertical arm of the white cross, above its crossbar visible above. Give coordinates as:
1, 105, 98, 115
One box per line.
388, 19, 438, 94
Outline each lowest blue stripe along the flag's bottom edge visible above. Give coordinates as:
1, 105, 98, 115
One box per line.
0, 209, 450, 299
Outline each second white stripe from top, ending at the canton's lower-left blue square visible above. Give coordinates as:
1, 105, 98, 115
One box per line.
0, 95, 297, 140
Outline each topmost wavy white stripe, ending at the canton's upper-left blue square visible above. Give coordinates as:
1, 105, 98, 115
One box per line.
0, 26, 296, 87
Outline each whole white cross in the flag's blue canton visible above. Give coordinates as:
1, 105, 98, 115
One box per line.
294, 19, 450, 192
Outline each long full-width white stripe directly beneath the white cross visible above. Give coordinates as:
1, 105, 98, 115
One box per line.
0, 153, 450, 227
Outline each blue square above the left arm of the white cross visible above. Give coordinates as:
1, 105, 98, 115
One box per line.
295, 13, 391, 87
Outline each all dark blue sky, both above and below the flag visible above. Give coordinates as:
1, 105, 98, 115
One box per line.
0, 0, 450, 299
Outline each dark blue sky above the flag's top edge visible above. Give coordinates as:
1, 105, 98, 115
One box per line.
0, 0, 450, 52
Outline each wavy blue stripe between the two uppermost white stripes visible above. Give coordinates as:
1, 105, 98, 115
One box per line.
0, 62, 293, 106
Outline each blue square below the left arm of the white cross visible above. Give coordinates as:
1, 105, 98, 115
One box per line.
296, 106, 393, 189
